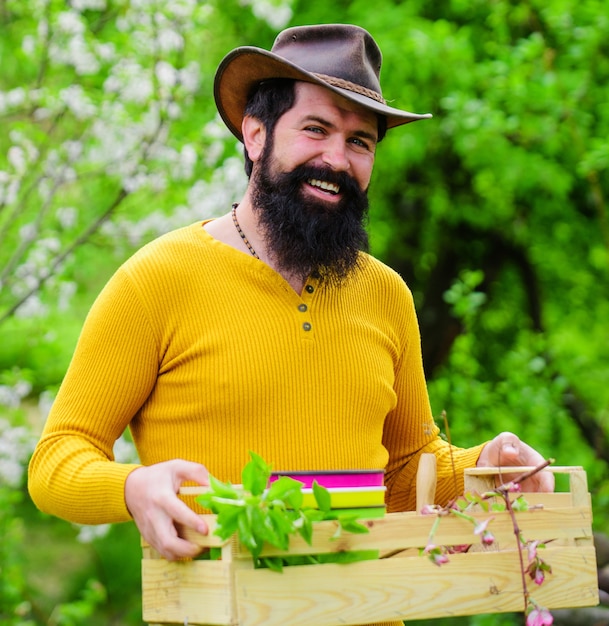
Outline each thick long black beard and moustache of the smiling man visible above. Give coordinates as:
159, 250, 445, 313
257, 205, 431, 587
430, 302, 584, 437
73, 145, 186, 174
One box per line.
252, 145, 368, 286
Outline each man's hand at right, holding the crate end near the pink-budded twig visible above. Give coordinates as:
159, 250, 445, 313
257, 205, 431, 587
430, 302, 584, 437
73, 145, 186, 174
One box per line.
476, 432, 554, 492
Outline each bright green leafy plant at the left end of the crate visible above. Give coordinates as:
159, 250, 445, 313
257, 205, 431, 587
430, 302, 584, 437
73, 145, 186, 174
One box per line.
197, 452, 378, 572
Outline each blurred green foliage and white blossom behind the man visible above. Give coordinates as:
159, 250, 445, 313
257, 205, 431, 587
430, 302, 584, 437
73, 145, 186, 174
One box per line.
0, 0, 609, 626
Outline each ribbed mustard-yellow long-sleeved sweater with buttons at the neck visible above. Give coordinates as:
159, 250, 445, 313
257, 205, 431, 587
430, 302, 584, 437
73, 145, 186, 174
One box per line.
29, 223, 480, 524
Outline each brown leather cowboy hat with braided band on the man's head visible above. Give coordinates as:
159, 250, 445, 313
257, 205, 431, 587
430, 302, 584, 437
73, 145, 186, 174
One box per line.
214, 24, 431, 141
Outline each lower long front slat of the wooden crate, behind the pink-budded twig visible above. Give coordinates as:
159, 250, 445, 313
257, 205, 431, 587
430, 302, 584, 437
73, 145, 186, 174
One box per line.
236, 547, 598, 626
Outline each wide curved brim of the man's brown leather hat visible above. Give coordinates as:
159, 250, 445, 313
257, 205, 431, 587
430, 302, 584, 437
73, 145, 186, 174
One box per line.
214, 46, 432, 141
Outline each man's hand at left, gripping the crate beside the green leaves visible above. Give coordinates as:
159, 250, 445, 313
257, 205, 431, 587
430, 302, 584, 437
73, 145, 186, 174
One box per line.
125, 459, 209, 560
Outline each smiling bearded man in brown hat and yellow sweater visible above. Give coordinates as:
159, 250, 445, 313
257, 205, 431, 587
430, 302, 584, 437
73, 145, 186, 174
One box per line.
29, 24, 552, 608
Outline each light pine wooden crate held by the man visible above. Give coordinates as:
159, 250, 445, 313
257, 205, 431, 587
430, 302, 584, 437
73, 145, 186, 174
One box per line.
142, 467, 598, 626
